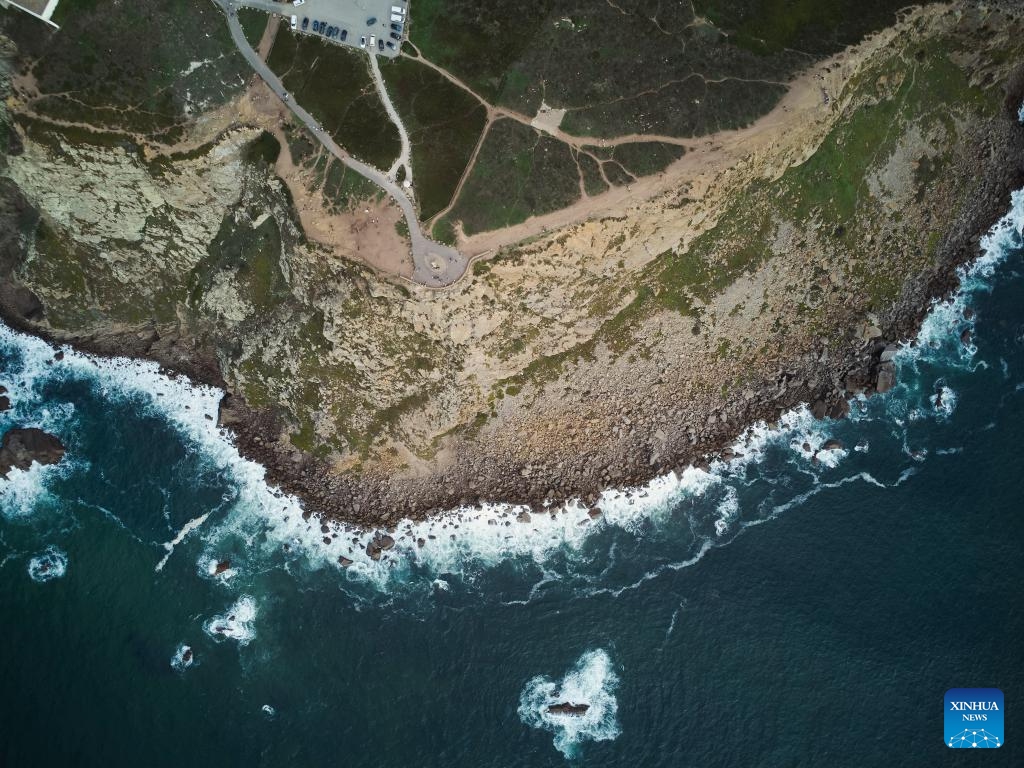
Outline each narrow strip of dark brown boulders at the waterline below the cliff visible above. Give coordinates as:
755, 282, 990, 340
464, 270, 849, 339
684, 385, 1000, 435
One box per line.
0, 109, 1024, 530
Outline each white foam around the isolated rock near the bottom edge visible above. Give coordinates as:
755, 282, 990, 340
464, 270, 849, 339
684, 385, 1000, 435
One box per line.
518, 649, 621, 758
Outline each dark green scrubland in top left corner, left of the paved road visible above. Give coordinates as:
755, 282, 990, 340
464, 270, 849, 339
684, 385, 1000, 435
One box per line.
3, 0, 249, 141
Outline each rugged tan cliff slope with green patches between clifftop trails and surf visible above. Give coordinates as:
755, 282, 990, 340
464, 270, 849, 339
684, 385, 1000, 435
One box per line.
0, 3, 1024, 524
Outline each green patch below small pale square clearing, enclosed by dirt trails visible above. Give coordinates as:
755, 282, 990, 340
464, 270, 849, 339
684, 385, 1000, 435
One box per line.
449, 120, 580, 234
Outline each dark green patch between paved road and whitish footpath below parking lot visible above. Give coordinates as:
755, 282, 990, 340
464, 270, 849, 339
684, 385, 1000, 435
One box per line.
267, 29, 401, 168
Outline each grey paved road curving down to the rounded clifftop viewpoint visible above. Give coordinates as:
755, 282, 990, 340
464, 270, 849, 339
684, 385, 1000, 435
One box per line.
222, 0, 469, 288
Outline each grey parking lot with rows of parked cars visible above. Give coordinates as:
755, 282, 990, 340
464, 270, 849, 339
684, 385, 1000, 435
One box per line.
286, 0, 409, 57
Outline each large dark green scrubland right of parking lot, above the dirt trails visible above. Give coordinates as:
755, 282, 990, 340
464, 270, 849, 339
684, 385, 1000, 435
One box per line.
411, 0, 917, 136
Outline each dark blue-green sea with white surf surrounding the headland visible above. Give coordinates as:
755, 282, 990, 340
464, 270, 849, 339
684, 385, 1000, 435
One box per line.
0, 197, 1024, 767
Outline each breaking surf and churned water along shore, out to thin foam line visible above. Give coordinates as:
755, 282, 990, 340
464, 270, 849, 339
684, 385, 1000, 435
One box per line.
0, 185, 1024, 602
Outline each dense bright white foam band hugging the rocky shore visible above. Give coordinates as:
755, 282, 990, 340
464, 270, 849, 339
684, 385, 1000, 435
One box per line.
0, 190, 1024, 587
